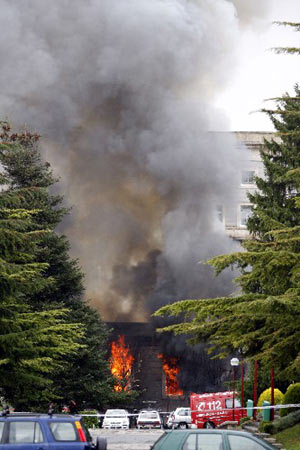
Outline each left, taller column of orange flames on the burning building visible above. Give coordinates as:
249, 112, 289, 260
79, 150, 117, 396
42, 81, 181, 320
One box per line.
110, 336, 134, 392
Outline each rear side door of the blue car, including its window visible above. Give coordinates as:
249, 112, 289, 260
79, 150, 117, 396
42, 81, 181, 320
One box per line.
1, 419, 49, 450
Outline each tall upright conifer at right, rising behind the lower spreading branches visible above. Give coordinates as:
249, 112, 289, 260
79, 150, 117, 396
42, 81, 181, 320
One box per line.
247, 85, 300, 240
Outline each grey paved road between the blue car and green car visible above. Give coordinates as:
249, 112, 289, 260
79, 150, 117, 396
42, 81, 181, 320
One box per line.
90, 428, 164, 450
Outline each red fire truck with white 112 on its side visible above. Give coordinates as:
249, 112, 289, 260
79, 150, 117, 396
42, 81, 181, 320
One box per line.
190, 391, 246, 428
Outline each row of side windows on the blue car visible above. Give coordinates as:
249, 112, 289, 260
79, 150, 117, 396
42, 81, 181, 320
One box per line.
0, 421, 77, 444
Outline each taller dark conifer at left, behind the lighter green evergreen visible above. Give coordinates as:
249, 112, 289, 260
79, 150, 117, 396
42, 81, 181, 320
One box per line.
0, 122, 113, 406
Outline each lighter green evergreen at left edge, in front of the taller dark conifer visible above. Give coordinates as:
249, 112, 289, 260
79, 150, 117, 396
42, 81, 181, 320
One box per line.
0, 206, 82, 409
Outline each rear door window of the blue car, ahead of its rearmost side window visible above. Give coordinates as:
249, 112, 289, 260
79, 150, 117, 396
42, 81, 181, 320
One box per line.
8, 422, 43, 444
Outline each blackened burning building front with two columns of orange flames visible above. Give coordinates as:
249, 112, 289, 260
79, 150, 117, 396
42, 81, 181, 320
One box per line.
107, 322, 228, 411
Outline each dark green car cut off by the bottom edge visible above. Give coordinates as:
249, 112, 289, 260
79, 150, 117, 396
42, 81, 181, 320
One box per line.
151, 429, 277, 450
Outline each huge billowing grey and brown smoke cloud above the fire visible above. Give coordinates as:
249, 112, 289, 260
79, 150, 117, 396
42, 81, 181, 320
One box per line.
0, 0, 270, 321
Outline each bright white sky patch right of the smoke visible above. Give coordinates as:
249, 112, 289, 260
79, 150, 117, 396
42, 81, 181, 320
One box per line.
215, 0, 300, 131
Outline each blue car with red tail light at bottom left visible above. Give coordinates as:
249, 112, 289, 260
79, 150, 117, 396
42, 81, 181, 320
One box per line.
0, 413, 107, 450
